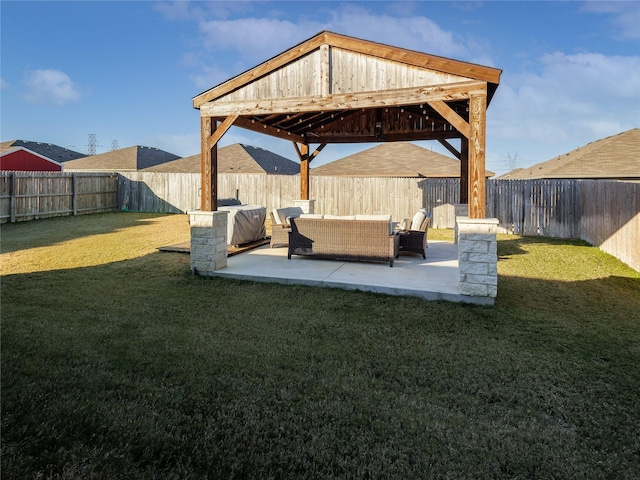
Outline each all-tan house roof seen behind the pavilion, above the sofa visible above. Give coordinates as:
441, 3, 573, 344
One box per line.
311, 142, 494, 178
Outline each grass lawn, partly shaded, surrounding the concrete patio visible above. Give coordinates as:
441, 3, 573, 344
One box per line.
0, 213, 640, 479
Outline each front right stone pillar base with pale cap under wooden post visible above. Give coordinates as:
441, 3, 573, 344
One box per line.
456, 217, 498, 299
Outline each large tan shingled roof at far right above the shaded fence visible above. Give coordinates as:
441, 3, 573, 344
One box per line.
500, 128, 640, 180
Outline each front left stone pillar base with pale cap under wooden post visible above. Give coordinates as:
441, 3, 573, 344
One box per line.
189, 210, 229, 275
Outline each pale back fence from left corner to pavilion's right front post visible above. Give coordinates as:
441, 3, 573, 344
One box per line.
118, 172, 460, 223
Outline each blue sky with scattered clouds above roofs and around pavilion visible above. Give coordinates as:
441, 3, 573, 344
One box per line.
0, 0, 640, 174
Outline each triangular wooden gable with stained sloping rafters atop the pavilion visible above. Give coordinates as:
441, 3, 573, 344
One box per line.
193, 32, 501, 108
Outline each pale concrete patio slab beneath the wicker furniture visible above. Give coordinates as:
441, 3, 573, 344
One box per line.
202, 240, 493, 305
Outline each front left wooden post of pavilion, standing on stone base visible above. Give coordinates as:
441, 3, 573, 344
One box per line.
200, 117, 218, 212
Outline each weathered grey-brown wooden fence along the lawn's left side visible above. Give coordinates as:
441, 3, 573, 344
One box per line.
0, 172, 118, 223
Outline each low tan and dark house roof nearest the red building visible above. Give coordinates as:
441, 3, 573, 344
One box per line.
64, 145, 180, 172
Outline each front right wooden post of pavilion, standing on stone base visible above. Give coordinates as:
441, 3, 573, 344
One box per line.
468, 94, 487, 218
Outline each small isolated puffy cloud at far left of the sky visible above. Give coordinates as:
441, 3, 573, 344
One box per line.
23, 70, 82, 105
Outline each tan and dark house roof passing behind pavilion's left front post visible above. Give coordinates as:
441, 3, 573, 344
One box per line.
145, 143, 300, 175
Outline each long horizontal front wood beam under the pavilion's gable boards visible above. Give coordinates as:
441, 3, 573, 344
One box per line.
200, 81, 487, 118
